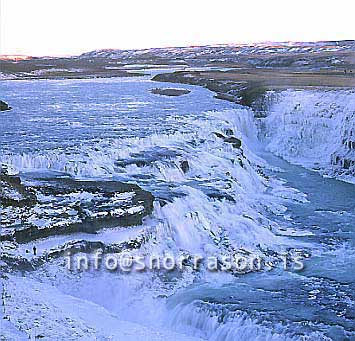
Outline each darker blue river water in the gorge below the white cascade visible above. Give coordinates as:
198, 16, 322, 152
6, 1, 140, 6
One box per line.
167, 153, 355, 340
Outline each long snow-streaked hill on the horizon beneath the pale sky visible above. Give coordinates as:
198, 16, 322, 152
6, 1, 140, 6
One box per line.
79, 40, 355, 67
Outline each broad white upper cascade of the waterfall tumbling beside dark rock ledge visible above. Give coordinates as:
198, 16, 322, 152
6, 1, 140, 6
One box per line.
1, 109, 304, 252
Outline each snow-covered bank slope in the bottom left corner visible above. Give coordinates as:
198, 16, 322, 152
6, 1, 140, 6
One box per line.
5, 275, 203, 341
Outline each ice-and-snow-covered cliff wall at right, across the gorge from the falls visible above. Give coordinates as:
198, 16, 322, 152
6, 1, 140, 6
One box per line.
259, 89, 355, 182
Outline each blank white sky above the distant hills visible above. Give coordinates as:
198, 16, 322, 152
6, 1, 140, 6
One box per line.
0, 0, 355, 56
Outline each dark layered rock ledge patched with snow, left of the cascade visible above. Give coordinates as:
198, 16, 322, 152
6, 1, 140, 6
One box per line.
0, 173, 154, 243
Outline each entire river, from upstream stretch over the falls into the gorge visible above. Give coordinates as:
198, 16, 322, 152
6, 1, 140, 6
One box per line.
0, 77, 355, 340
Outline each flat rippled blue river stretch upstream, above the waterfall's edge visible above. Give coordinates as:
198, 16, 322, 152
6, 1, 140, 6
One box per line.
0, 77, 232, 154
